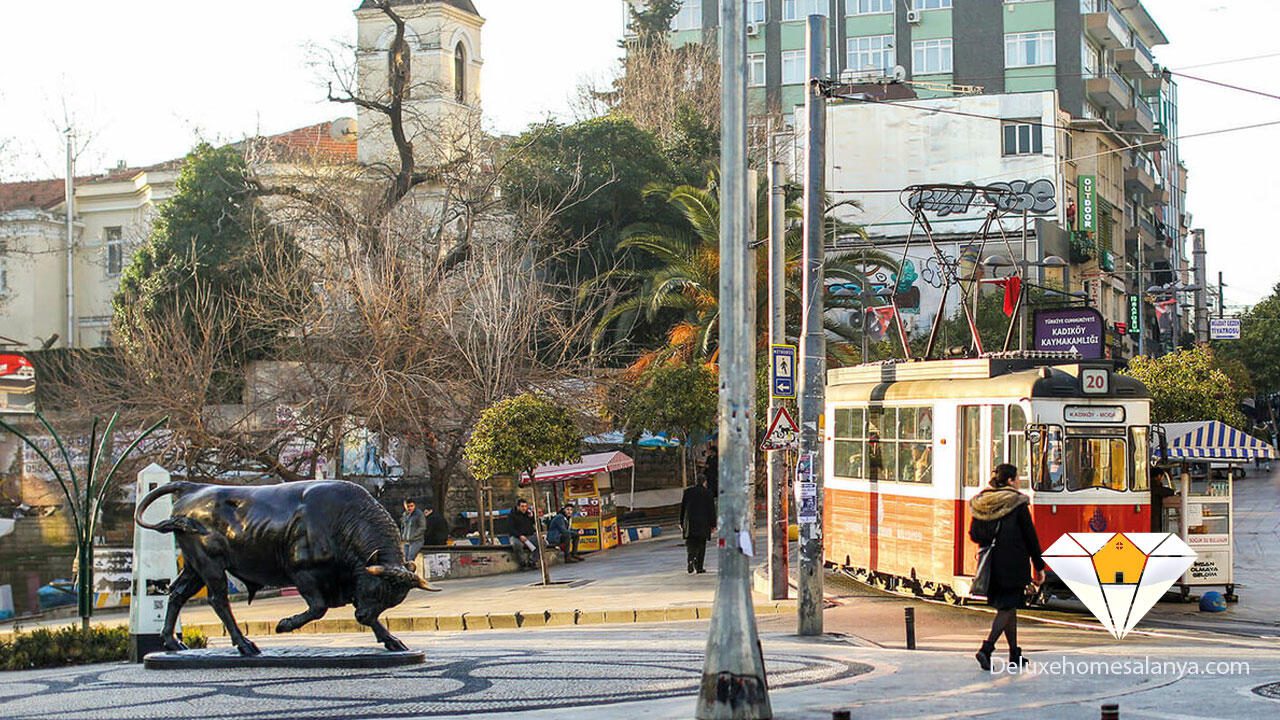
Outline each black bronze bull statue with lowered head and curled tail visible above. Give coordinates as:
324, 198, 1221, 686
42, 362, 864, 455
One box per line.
133, 480, 434, 655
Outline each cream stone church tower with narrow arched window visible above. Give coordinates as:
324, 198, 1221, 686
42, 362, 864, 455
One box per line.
356, 0, 484, 167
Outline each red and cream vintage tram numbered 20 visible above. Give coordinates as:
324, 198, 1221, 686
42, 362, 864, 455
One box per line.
823, 357, 1151, 601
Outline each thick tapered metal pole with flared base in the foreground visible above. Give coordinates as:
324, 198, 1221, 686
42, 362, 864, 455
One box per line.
696, 0, 773, 720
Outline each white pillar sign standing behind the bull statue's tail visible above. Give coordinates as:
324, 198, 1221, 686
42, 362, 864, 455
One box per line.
129, 462, 180, 662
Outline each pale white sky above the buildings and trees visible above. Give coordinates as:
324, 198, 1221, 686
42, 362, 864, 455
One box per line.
0, 0, 1280, 307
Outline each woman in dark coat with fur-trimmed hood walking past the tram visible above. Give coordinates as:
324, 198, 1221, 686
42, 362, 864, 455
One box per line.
969, 464, 1044, 670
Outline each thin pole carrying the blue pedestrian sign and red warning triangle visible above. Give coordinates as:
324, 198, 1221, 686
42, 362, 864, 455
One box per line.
768, 160, 790, 600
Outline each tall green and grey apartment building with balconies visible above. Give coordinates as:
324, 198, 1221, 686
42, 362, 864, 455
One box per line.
626, 0, 1187, 355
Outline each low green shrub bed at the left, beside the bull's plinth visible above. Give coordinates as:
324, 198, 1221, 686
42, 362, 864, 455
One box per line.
0, 625, 209, 670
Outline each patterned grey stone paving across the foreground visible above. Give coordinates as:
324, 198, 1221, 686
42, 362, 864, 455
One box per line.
0, 621, 1280, 720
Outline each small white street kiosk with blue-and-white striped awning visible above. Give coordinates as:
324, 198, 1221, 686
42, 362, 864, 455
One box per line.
1161, 420, 1275, 601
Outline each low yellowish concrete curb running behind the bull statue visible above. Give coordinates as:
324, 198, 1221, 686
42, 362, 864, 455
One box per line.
183, 600, 796, 638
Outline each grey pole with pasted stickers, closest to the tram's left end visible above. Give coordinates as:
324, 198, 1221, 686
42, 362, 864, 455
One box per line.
796, 15, 827, 635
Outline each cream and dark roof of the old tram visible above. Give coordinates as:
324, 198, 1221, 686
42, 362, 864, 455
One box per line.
827, 357, 1151, 401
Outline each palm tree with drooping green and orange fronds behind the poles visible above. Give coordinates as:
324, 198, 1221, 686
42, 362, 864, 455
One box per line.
584, 173, 897, 373
